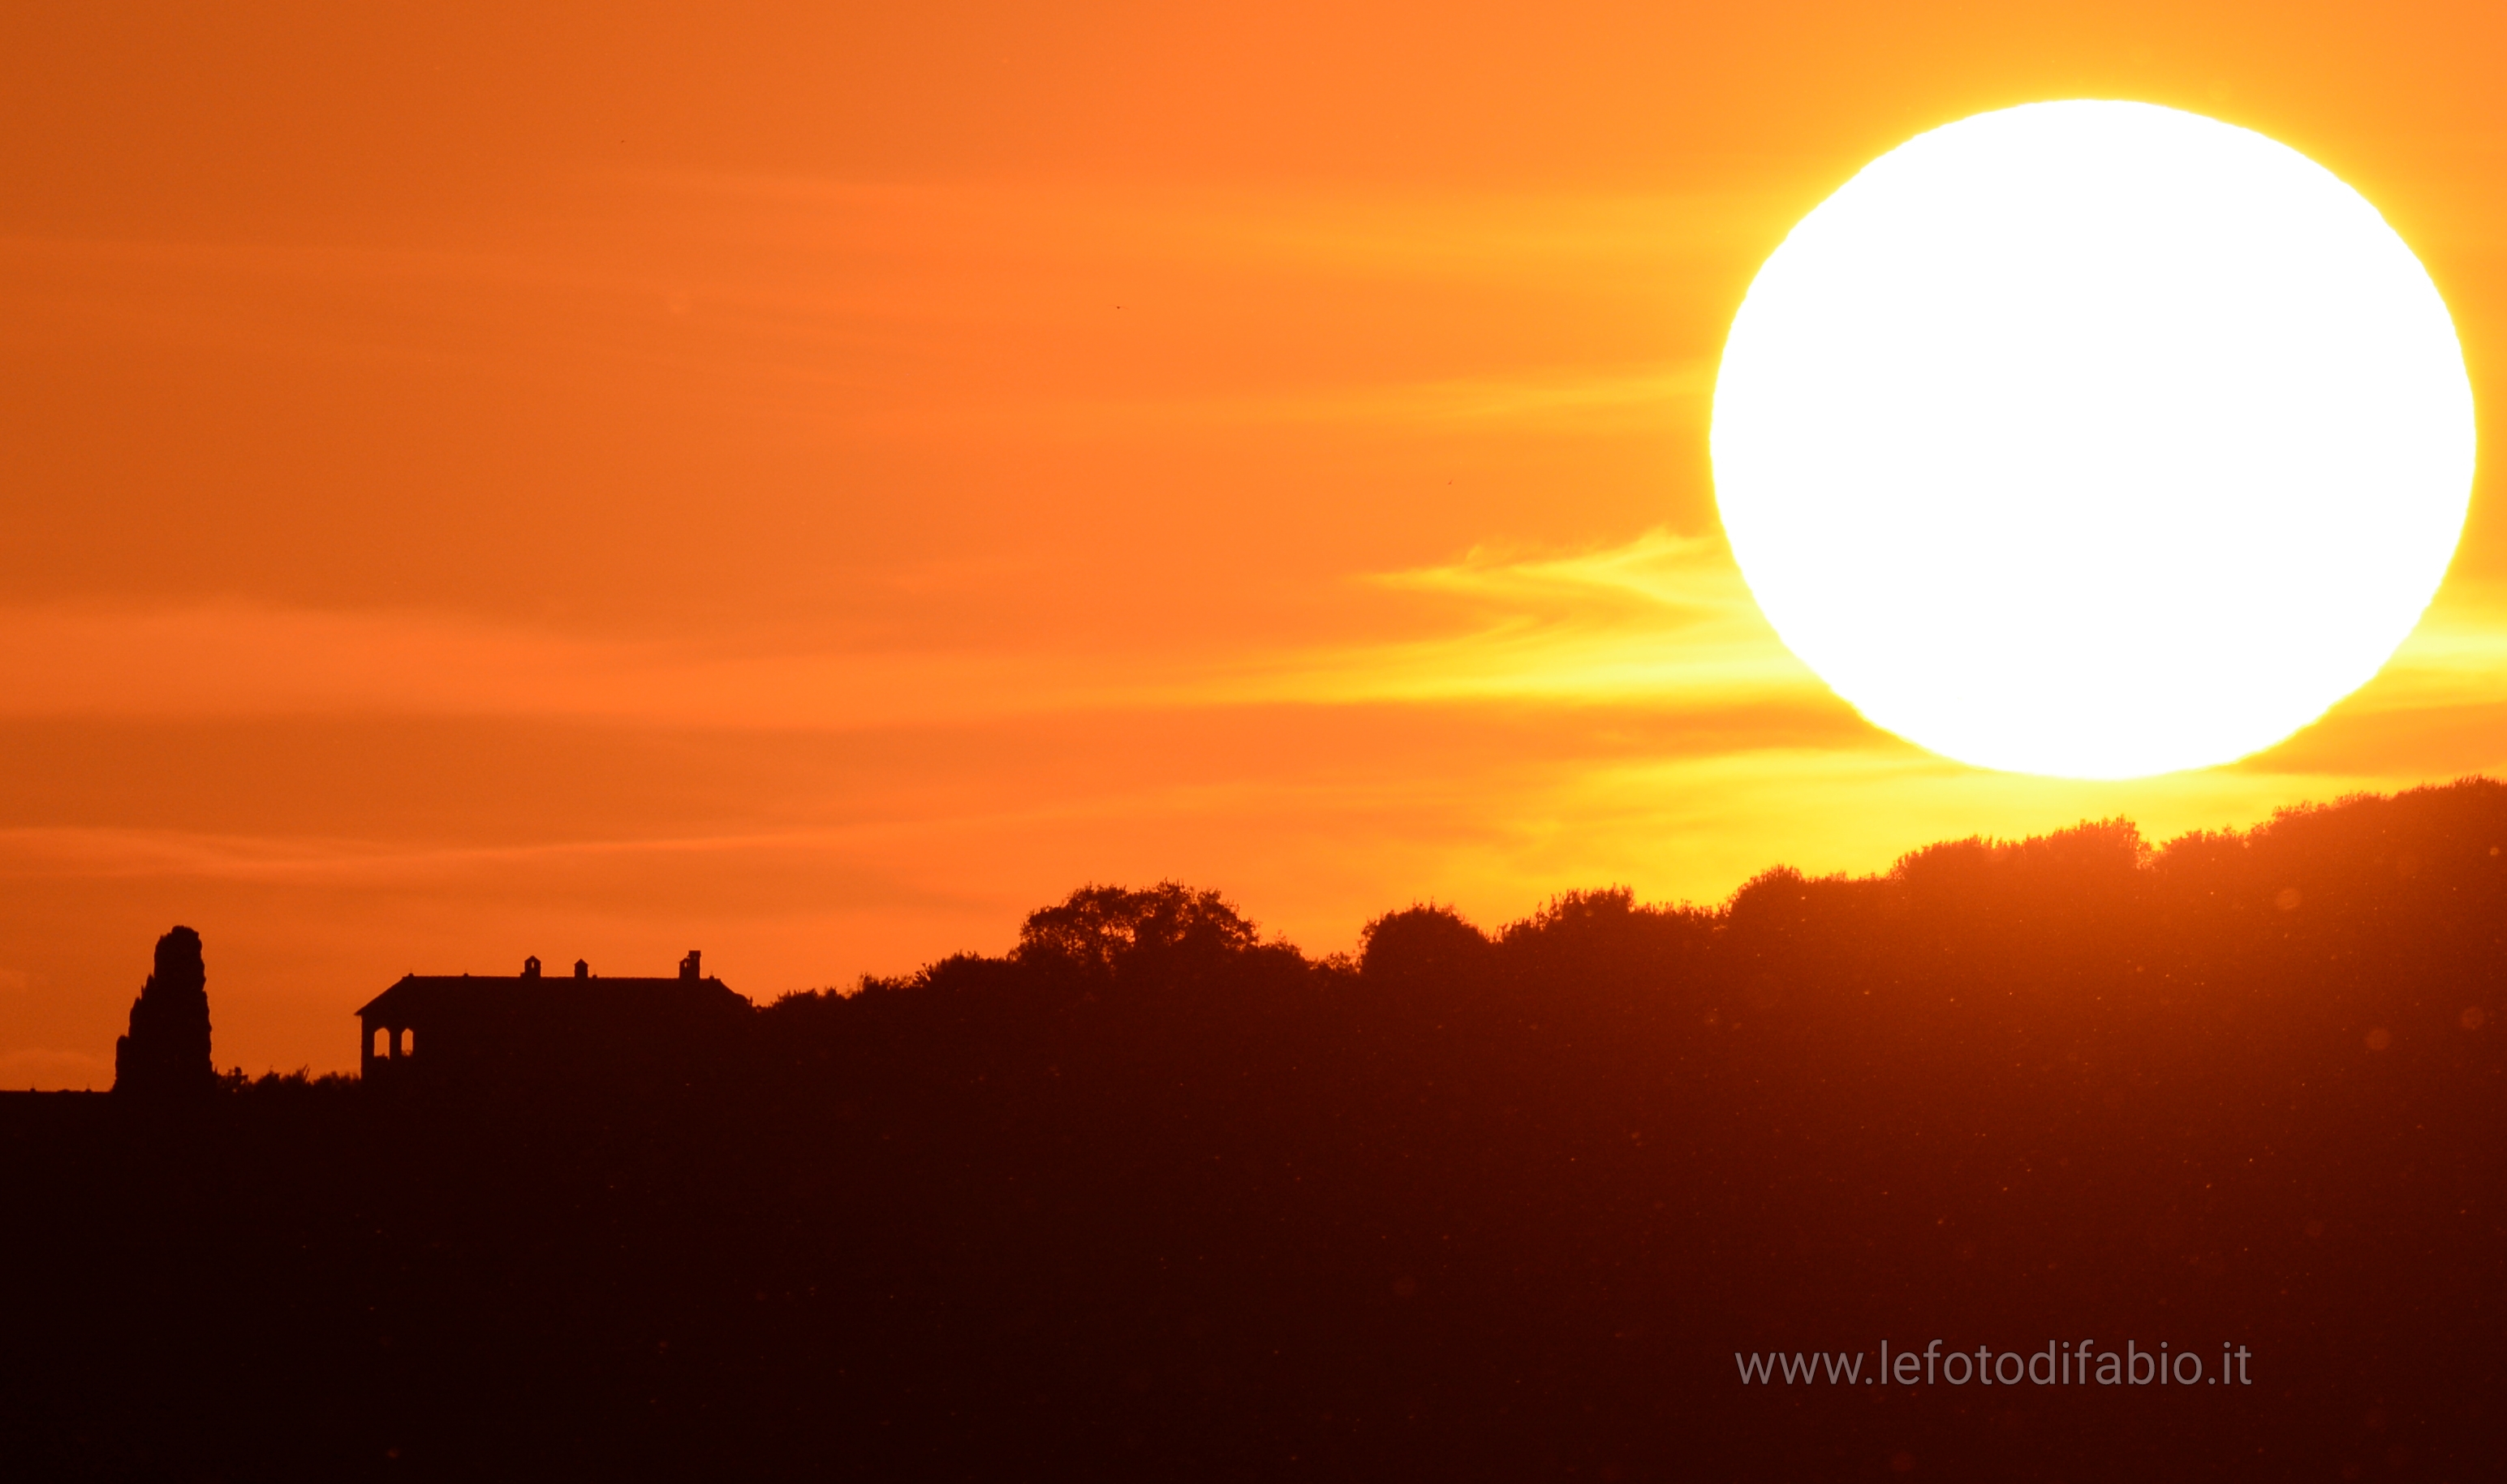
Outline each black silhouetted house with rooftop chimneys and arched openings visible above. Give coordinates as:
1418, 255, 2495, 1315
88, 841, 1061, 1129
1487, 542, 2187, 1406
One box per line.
356, 950, 755, 1088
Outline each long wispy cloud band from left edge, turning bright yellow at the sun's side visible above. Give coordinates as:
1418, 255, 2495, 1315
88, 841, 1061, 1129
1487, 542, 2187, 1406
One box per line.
0, 531, 1825, 727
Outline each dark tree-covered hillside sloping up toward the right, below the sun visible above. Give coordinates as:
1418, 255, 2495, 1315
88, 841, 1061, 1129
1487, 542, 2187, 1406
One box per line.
0, 782, 2507, 1482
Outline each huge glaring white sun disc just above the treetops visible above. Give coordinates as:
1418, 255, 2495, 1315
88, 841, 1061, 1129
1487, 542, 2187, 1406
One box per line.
1712, 103, 2472, 777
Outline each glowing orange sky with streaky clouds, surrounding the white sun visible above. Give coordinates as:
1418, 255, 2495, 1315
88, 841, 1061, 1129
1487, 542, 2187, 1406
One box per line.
0, 0, 2507, 1086
